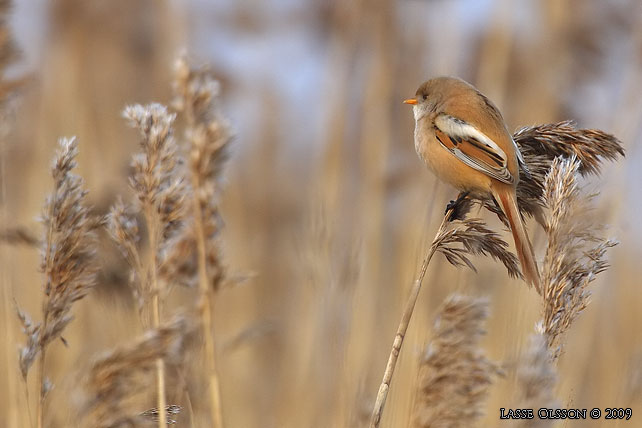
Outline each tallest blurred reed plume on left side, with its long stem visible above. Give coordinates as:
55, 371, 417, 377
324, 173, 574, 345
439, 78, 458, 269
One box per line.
167, 57, 232, 428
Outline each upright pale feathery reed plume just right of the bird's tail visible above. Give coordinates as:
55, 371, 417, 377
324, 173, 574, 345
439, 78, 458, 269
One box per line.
541, 156, 617, 358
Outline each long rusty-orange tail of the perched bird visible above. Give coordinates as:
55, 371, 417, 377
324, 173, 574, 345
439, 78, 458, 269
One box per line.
493, 188, 541, 294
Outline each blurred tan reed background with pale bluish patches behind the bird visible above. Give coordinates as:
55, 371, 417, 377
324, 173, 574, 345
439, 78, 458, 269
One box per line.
0, 0, 642, 427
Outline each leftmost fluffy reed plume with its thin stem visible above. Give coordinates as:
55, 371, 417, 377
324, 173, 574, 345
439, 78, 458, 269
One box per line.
18, 138, 98, 427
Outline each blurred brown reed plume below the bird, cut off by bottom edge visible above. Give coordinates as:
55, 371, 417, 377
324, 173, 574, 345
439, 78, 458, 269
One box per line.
414, 295, 500, 428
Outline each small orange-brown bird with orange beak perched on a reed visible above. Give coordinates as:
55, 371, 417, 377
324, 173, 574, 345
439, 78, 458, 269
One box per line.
404, 76, 541, 293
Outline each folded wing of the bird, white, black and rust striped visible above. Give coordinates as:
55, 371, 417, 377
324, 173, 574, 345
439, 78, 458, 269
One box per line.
435, 114, 519, 184
